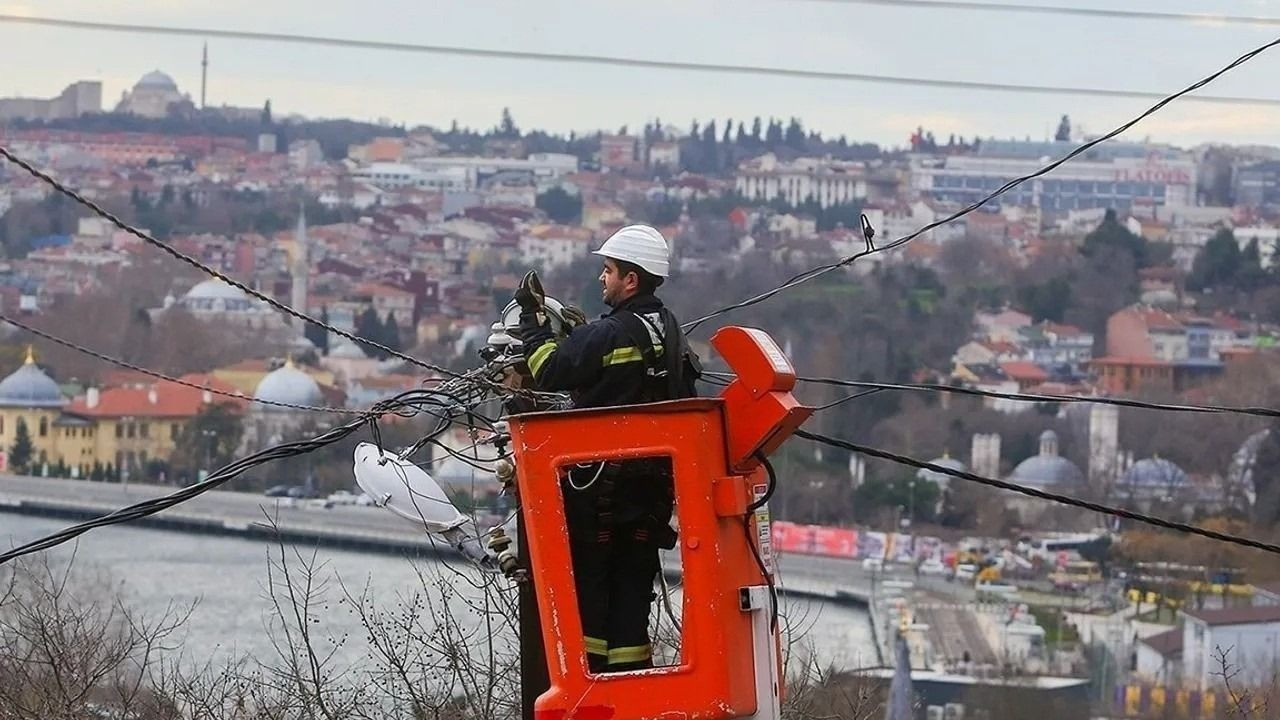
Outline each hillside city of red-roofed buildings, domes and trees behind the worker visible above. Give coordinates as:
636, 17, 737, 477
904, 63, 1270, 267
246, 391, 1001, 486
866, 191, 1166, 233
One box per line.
0, 70, 1280, 719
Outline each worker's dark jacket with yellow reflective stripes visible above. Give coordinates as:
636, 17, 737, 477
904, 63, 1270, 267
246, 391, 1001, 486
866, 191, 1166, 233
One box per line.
520, 289, 694, 407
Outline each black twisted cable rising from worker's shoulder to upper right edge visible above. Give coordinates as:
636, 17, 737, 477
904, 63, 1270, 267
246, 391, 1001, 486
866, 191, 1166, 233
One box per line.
681, 38, 1280, 333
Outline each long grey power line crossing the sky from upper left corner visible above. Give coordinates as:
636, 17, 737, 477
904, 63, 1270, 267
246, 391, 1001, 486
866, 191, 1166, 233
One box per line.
0, 14, 1280, 105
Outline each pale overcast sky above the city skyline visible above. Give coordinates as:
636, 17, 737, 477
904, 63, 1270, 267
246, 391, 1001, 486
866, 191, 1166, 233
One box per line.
0, 0, 1280, 146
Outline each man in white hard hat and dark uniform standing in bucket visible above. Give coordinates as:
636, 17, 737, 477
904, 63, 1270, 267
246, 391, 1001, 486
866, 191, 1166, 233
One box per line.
516, 225, 699, 673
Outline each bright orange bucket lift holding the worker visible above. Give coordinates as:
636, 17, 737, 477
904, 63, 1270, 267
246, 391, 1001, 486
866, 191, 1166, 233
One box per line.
508, 327, 812, 720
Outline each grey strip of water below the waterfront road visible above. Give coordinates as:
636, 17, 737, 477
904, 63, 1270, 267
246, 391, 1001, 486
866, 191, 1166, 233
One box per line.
0, 512, 876, 669
